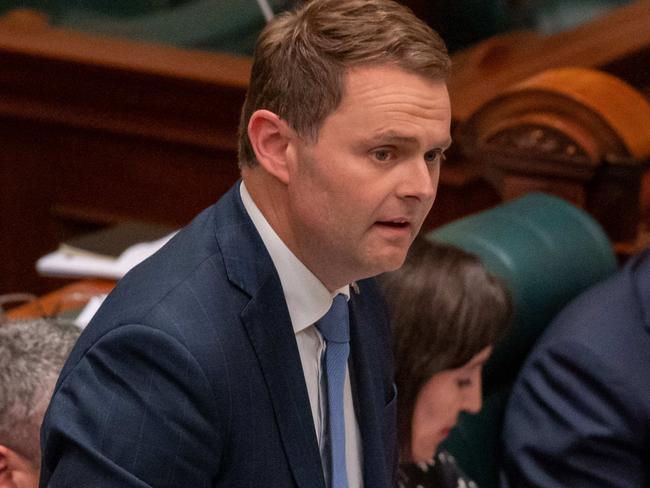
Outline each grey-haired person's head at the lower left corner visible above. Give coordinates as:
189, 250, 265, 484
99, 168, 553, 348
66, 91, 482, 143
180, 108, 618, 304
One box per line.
0, 319, 81, 488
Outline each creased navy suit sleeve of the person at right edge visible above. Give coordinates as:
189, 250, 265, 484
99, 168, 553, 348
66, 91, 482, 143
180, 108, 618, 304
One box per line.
503, 342, 647, 488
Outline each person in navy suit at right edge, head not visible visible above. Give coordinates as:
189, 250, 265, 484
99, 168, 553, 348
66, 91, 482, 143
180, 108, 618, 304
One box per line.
503, 251, 650, 488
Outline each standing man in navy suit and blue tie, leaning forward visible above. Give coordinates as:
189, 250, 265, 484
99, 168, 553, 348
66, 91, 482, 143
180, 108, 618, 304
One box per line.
36, 0, 450, 488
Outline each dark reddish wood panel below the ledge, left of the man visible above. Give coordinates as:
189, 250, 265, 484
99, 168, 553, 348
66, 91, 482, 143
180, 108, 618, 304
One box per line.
0, 118, 239, 294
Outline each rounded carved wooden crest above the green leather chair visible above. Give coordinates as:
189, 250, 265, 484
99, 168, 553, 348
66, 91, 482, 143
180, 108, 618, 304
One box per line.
459, 68, 650, 241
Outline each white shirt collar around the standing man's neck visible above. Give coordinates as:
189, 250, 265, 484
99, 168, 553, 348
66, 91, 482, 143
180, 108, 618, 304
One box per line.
239, 181, 350, 334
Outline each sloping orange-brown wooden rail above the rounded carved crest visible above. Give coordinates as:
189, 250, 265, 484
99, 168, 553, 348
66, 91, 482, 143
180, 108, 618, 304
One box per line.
449, 0, 650, 121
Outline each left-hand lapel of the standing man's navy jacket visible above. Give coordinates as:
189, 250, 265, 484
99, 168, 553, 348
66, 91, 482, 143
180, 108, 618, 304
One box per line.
217, 185, 325, 488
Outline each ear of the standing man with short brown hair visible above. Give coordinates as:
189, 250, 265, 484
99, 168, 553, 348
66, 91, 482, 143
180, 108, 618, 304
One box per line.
248, 110, 295, 184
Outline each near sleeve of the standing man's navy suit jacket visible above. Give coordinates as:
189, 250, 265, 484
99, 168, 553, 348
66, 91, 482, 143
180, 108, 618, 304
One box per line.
41, 325, 227, 488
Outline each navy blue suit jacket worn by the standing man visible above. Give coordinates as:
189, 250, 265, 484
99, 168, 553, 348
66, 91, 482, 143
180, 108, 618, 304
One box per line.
41, 185, 396, 488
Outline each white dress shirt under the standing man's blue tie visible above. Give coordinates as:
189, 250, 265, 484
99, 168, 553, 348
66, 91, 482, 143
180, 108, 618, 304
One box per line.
239, 182, 363, 488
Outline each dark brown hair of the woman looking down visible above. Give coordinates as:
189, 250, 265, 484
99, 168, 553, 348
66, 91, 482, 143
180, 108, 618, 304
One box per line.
379, 237, 512, 460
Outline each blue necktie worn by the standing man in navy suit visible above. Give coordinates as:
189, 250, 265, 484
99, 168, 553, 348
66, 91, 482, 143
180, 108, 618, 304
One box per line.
316, 294, 350, 488
